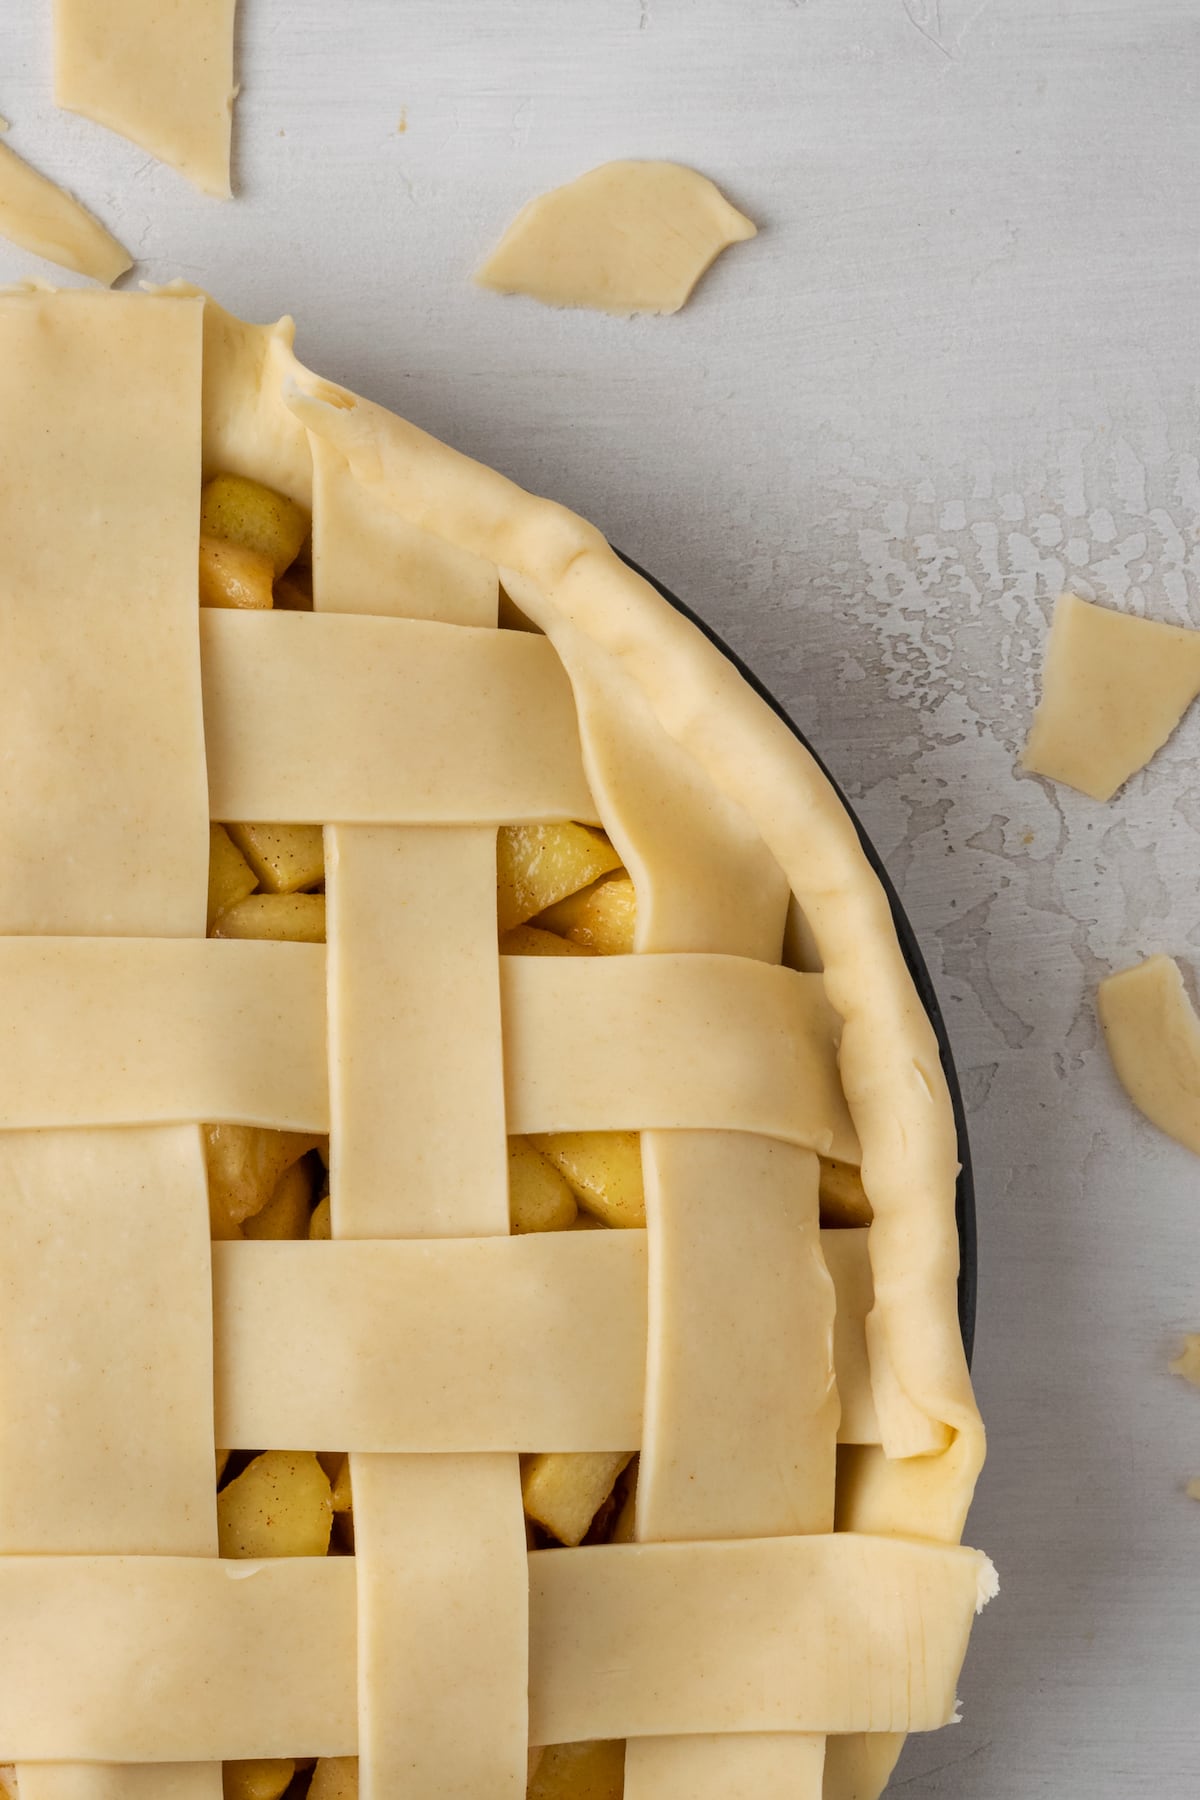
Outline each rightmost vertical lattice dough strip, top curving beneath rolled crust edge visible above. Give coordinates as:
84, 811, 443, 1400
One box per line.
496, 589, 834, 1800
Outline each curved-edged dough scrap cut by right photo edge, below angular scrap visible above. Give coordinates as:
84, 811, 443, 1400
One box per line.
1097, 956, 1200, 1156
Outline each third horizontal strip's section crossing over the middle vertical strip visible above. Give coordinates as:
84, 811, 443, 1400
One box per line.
212, 1231, 646, 1454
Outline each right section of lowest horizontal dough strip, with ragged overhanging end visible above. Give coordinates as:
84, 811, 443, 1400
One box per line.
528, 1535, 995, 1744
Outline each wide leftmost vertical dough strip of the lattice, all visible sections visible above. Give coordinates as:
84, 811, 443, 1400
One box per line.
0, 295, 221, 1800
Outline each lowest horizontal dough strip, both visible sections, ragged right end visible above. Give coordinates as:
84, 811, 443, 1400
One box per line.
0, 1533, 993, 1762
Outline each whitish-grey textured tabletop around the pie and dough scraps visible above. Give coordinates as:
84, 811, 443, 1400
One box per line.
0, 0, 1200, 1800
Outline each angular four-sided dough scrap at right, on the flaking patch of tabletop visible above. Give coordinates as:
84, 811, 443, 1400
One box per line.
1022, 594, 1200, 799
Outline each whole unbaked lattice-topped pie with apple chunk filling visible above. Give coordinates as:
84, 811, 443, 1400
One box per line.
0, 288, 993, 1800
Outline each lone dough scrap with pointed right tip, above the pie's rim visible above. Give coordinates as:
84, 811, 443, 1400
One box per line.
475, 162, 757, 313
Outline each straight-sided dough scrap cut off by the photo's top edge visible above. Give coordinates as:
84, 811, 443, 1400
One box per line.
54, 0, 237, 200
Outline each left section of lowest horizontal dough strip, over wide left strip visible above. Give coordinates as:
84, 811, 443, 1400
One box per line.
0, 1555, 358, 1766
